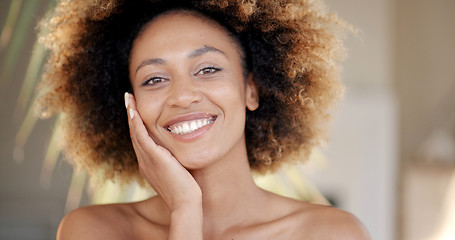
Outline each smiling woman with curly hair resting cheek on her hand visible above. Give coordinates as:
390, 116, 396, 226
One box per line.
40, 0, 369, 240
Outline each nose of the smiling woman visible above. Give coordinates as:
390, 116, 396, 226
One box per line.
168, 77, 202, 108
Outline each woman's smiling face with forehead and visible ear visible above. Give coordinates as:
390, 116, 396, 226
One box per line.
129, 12, 258, 169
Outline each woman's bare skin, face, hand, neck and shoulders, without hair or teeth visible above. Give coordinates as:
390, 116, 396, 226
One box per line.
57, 11, 370, 240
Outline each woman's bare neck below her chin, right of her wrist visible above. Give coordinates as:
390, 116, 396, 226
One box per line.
191, 137, 265, 231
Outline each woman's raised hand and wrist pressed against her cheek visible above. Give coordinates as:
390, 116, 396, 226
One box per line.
125, 93, 202, 239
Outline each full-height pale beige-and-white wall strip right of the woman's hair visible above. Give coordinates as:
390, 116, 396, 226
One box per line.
307, 0, 399, 240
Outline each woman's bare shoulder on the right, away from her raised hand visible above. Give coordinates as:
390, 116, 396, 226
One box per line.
256, 194, 371, 240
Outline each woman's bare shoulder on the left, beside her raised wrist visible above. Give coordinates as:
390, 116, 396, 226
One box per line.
57, 199, 168, 240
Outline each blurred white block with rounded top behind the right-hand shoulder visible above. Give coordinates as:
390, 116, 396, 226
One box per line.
304, 89, 398, 240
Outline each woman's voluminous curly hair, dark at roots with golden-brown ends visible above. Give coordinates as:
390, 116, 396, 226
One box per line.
38, 0, 344, 185
